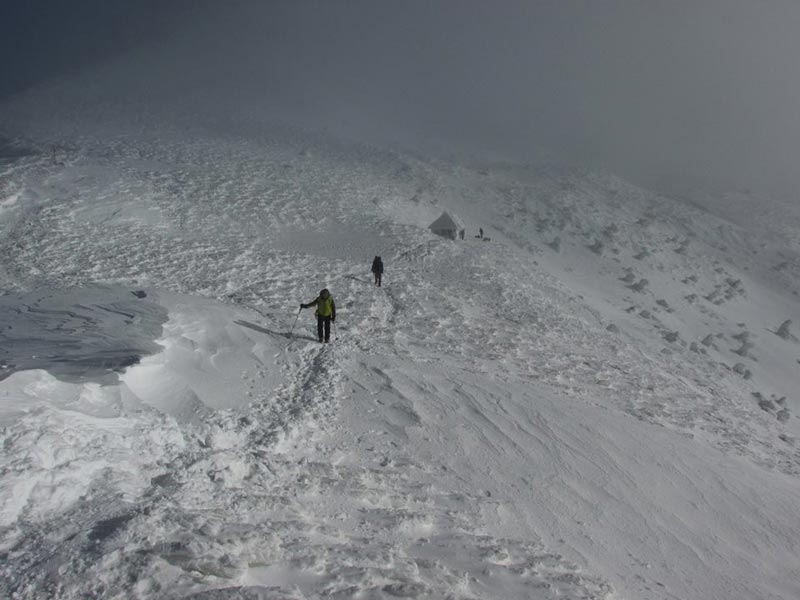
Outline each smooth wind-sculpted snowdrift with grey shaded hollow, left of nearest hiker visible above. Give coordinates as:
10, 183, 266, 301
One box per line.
0, 286, 286, 421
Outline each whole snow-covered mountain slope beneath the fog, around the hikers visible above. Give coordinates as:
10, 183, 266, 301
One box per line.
0, 77, 800, 600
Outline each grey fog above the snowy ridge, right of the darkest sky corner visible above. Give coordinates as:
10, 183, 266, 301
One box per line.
0, 0, 800, 197
